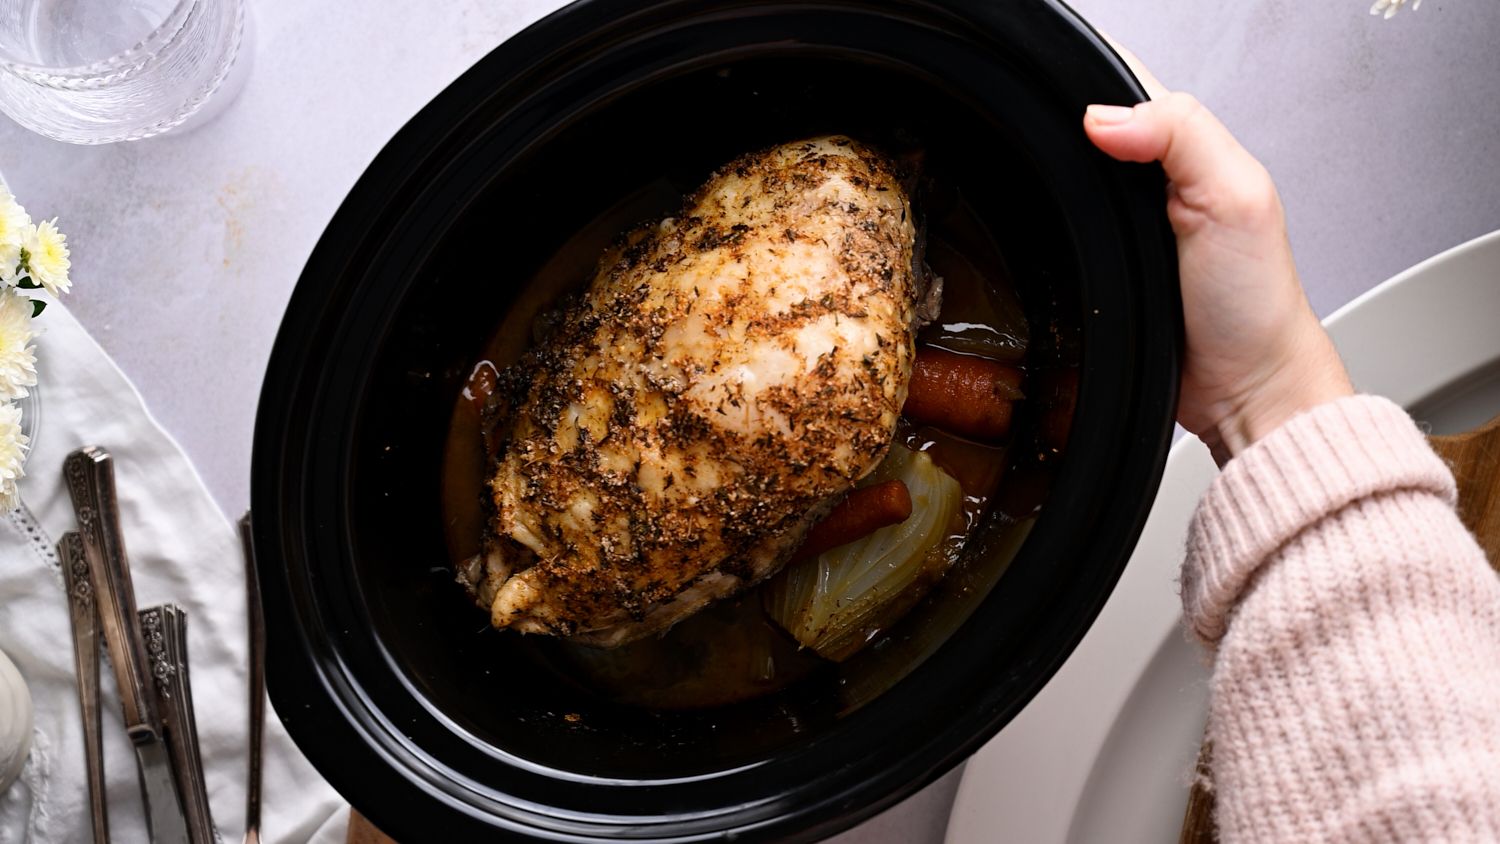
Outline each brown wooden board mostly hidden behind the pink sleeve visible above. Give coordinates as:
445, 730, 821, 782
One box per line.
1179, 417, 1500, 844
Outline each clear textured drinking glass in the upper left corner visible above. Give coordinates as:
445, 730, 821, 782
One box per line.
0, 0, 248, 144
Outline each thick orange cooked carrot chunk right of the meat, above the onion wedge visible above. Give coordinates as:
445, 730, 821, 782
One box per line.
902, 346, 1023, 441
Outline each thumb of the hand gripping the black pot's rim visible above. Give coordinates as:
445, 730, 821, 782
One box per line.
1083, 93, 1263, 199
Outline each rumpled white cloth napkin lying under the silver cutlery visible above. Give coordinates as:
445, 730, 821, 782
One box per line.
0, 303, 348, 844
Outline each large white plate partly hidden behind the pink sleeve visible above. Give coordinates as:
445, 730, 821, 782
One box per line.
947, 231, 1500, 844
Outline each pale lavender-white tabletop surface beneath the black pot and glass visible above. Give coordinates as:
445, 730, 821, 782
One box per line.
0, 0, 1500, 844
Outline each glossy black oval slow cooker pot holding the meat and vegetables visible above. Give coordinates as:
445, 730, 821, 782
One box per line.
252, 0, 1182, 843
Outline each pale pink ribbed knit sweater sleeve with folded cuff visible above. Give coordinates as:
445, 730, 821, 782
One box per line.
1182, 396, 1500, 843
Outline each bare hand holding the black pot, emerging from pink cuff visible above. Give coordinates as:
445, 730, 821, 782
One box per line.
1083, 51, 1353, 465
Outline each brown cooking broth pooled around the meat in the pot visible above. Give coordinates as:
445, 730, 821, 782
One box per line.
441, 171, 1068, 711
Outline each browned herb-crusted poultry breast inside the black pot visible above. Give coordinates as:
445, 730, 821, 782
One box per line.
459, 136, 936, 646
